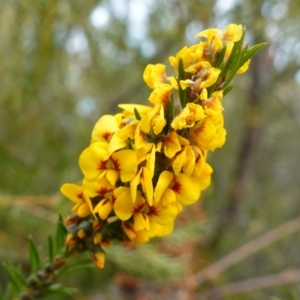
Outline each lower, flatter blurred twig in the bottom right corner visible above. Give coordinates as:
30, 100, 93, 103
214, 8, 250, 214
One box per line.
196, 270, 300, 300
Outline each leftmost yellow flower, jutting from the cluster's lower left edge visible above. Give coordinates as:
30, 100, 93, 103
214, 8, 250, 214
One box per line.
60, 183, 91, 218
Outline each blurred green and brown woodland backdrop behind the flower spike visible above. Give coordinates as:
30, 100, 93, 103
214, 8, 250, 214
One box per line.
0, 0, 300, 300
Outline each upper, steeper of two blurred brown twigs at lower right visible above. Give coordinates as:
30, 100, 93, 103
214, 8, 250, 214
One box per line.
189, 217, 300, 287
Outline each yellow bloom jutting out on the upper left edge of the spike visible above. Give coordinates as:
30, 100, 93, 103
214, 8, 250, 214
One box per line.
143, 64, 167, 89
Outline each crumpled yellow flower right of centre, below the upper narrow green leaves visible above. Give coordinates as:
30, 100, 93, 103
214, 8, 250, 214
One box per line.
171, 103, 205, 130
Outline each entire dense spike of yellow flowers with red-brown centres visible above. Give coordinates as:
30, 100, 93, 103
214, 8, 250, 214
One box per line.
61, 24, 258, 266
